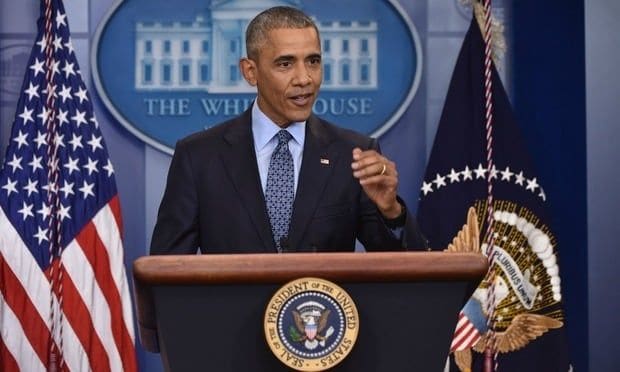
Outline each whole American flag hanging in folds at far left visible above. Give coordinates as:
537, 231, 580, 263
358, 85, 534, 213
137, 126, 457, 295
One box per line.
0, 0, 137, 372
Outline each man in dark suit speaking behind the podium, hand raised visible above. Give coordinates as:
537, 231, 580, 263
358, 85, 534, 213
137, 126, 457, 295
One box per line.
151, 7, 425, 254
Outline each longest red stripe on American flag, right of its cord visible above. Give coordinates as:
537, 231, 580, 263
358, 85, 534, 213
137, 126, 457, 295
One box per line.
76, 222, 137, 371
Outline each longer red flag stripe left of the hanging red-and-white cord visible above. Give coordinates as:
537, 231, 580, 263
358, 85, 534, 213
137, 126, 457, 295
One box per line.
0, 253, 51, 365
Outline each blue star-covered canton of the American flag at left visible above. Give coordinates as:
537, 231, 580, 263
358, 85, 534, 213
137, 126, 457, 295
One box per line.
0, 2, 116, 269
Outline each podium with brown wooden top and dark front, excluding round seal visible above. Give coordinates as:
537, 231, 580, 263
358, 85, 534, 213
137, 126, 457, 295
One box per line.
134, 252, 487, 372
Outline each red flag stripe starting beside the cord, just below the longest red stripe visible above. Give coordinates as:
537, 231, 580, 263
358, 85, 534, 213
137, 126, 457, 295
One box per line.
56, 262, 110, 372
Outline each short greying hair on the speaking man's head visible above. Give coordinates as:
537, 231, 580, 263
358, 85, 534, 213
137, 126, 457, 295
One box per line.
245, 6, 320, 60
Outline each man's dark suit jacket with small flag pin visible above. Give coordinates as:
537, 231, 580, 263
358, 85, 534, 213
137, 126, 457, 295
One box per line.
151, 109, 424, 254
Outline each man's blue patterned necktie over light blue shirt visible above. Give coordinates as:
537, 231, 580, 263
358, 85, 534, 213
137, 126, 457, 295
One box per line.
265, 130, 295, 252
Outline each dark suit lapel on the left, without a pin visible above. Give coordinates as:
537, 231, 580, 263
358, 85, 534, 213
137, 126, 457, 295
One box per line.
220, 110, 276, 252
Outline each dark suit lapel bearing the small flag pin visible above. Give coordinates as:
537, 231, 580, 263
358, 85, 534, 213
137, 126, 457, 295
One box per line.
289, 115, 339, 248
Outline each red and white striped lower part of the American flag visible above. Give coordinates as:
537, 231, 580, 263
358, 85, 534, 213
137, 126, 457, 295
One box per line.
0, 201, 137, 371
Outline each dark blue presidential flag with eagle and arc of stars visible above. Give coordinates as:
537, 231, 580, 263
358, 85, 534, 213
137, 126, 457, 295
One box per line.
418, 8, 569, 372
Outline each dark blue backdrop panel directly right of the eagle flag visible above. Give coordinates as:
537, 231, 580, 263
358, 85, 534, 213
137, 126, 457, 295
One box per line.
512, 0, 588, 371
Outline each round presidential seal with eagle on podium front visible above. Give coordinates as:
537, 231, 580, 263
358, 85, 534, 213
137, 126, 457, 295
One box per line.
264, 278, 359, 371
